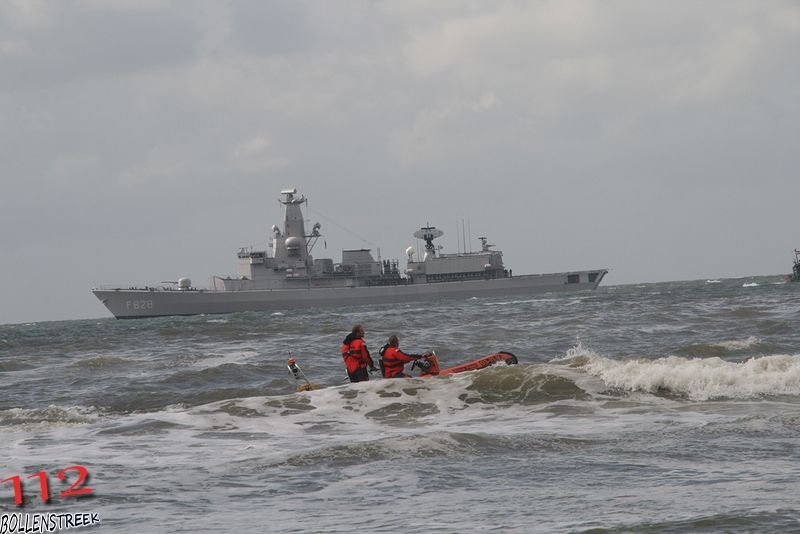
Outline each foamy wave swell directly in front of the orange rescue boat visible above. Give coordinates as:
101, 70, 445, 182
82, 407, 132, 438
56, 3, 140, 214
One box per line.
193, 364, 590, 434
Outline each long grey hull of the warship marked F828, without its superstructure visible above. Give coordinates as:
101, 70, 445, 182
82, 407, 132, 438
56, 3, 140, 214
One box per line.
92, 269, 608, 319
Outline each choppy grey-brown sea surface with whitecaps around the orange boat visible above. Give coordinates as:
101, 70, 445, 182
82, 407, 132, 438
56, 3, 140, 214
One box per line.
0, 277, 800, 533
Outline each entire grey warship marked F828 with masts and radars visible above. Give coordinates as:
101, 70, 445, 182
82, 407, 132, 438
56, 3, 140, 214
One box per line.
92, 189, 608, 319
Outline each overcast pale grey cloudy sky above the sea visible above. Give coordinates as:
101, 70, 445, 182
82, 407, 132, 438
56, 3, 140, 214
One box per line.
0, 0, 800, 324
